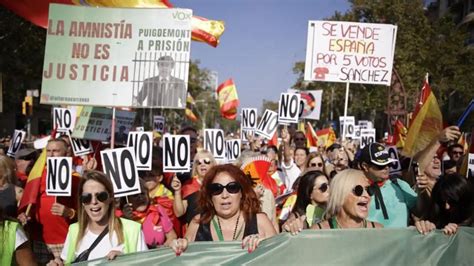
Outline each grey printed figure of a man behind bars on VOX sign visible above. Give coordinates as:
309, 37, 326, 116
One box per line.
136, 55, 186, 108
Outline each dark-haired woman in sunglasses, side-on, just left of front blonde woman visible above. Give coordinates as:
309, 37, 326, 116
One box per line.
282, 171, 329, 233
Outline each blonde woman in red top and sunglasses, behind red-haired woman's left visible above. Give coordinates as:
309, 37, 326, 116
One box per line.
171, 150, 216, 224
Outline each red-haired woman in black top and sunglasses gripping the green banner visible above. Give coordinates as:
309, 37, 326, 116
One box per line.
172, 164, 276, 255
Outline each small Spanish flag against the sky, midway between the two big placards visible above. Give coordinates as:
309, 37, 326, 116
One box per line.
217, 79, 240, 120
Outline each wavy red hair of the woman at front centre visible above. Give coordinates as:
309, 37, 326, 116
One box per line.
198, 164, 260, 223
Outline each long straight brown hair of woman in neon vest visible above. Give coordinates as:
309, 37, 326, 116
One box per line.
76, 170, 124, 249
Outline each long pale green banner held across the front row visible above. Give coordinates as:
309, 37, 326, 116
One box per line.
78, 228, 474, 266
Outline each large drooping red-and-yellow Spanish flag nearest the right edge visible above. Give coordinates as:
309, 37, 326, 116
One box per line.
402, 74, 443, 157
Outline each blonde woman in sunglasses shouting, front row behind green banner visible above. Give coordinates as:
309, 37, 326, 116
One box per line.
311, 169, 383, 229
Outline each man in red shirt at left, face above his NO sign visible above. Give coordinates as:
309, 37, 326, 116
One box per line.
18, 138, 80, 264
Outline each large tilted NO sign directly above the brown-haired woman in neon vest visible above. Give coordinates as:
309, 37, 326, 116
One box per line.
100, 147, 141, 197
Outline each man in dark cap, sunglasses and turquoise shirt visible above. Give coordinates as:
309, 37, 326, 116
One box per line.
359, 143, 417, 228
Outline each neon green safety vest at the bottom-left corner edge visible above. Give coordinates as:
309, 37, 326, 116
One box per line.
0, 220, 20, 265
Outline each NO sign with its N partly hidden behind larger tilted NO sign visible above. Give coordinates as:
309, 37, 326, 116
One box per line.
127, 131, 153, 170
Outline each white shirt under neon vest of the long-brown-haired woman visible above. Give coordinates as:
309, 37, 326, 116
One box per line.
61, 230, 148, 260
